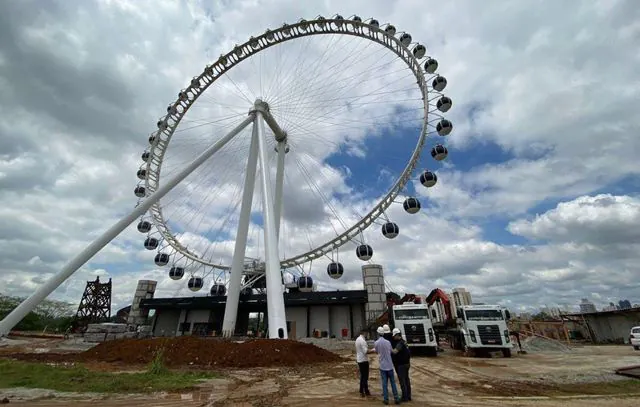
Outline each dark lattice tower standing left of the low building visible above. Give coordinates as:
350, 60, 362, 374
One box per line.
74, 277, 111, 330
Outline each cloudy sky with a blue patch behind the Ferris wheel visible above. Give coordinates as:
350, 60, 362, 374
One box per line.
0, 0, 640, 311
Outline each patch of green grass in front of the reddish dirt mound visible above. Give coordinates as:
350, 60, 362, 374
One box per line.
0, 352, 216, 393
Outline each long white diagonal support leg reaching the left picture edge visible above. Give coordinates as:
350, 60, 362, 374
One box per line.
0, 114, 255, 337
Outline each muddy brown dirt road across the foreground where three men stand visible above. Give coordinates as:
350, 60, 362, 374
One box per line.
0, 338, 640, 407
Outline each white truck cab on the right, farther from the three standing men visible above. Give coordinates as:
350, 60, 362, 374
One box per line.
456, 305, 513, 357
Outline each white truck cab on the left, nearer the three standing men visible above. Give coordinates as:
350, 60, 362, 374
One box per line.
391, 303, 438, 356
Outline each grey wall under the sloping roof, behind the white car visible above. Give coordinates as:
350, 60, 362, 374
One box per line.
584, 309, 640, 343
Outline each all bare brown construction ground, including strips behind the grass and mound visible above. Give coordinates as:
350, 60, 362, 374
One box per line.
0, 338, 640, 407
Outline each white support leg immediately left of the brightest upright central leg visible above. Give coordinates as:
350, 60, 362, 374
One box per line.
222, 123, 258, 338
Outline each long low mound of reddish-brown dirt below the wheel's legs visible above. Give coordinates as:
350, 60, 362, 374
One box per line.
75, 336, 342, 368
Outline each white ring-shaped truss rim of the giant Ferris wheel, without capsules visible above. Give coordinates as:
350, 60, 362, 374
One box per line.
144, 16, 440, 271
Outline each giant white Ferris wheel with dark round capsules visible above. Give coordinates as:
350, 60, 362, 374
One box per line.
134, 15, 453, 337
